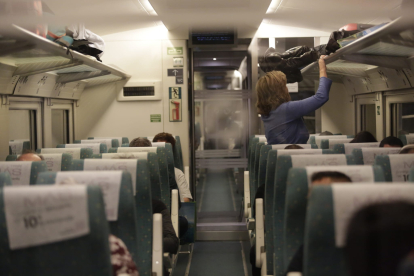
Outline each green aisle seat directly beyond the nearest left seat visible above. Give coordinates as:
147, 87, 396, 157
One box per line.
37, 171, 139, 263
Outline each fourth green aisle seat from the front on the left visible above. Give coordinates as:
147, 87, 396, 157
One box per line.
106, 147, 171, 210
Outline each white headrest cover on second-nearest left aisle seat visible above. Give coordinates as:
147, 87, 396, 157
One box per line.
55, 171, 122, 221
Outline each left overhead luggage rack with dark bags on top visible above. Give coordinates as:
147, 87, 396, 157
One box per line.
0, 25, 131, 99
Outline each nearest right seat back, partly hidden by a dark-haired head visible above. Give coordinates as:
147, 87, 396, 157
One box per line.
304, 183, 414, 276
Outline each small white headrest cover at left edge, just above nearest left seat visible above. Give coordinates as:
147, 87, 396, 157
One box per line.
0, 161, 32, 186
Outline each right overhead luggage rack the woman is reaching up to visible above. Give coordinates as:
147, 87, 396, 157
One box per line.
301, 17, 414, 78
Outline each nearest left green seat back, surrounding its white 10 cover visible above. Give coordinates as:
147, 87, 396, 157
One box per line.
0, 184, 113, 276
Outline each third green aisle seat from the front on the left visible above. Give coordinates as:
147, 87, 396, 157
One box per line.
68, 159, 152, 276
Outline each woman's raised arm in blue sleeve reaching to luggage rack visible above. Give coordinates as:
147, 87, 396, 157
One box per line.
287, 56, 332, 118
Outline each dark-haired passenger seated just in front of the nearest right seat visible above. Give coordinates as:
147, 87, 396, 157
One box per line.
286, 171, 352, 275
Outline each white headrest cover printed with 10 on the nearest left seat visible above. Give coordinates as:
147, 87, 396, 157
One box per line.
4, 185, 90, 250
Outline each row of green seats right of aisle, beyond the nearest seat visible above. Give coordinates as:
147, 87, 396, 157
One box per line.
244, 137, 414, 276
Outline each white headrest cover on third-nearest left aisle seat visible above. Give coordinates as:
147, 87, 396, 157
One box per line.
83, 159, 138, 195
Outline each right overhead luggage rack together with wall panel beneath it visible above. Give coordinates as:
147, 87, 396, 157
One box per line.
301, 17, 414, 94
